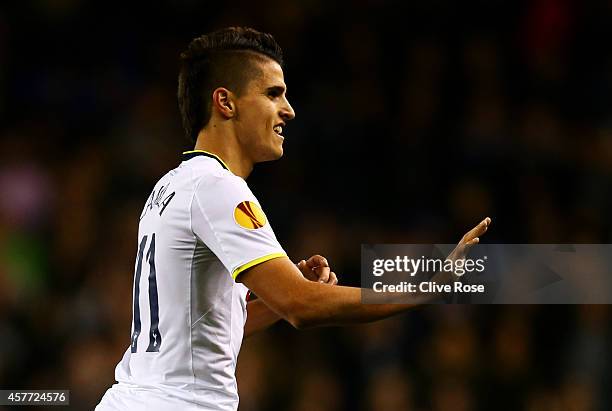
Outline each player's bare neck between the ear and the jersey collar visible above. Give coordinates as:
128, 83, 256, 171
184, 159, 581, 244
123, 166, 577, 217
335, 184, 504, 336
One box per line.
194, 125, 253, 180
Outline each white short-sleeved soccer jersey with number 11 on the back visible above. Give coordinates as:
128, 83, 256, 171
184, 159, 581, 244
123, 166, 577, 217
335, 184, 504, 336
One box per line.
96, 151, 286, 411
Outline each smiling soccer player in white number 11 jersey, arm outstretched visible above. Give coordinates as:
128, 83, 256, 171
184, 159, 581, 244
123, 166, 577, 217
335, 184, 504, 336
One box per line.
96, 28, 490, 411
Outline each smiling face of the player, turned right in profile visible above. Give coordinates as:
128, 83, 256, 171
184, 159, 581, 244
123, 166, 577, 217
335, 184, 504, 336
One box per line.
235, 59, 295, 163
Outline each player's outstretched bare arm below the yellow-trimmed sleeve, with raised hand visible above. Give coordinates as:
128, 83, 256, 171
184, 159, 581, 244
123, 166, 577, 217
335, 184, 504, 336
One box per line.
239, 218, 491, 328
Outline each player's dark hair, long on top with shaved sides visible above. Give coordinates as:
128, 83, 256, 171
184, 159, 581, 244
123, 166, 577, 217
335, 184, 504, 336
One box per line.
178, 27, 283, 142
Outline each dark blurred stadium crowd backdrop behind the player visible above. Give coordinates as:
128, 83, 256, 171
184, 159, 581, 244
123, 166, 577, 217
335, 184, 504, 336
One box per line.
0, 0, 612, 411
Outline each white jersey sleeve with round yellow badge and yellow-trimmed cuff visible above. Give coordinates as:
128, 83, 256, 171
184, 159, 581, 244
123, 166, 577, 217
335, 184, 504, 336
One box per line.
191, 176, 287, 279
